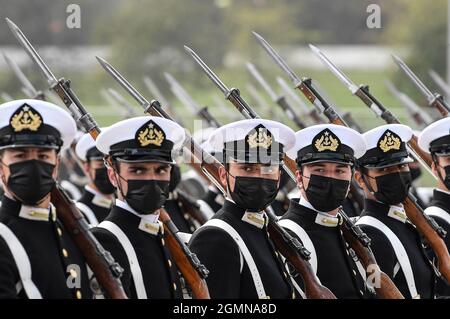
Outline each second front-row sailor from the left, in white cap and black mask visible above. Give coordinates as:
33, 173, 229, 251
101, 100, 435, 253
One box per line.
93, 116, 185, 299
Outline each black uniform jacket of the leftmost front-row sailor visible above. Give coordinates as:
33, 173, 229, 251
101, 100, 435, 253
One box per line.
0, 196, 92, 299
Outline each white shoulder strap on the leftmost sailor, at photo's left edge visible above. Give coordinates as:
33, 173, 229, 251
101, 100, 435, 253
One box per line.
0, 223, 42, 299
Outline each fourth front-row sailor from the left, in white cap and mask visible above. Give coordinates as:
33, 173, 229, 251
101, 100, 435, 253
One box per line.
280, 124, 372, 299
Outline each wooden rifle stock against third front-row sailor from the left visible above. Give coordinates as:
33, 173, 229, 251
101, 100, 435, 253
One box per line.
267, 218, 336, 299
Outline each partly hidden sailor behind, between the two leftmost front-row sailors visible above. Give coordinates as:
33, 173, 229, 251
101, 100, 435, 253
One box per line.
75, 134, 115, 226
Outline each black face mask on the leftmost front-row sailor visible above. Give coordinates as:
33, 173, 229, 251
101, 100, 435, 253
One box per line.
6, 160, 55, 206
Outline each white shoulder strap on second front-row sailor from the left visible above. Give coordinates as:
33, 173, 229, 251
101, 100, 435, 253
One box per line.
97, 220, 147, 299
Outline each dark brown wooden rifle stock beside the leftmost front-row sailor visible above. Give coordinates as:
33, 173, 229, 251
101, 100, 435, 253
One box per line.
51, 186, 127, 299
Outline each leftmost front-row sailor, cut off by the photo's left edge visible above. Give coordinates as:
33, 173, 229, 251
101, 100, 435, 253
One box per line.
0, 99, 92, 299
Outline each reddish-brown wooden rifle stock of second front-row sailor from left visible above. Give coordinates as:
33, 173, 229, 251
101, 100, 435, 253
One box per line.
159, 209, 210, 299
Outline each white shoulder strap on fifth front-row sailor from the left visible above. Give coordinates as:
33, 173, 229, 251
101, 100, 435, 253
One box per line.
356, 216, 420, 299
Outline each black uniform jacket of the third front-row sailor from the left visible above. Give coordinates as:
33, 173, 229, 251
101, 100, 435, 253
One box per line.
190, 200, 293, 299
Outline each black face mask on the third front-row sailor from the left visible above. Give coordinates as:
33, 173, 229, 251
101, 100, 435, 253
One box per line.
230, 176, 278, 212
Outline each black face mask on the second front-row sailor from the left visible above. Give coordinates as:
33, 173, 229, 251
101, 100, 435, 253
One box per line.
125, 179, 169, 214
